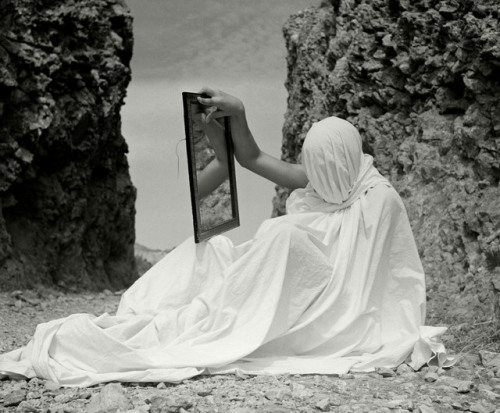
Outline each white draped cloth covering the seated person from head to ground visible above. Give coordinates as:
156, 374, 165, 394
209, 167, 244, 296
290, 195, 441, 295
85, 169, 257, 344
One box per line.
0, 118, 449, 386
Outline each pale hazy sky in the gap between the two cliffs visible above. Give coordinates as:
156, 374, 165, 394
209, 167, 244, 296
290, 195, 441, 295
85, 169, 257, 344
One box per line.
121, 0, 318, 249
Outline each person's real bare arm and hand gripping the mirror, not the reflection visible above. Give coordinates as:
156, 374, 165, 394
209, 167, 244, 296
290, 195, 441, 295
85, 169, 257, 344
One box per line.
198, 88, 308, 189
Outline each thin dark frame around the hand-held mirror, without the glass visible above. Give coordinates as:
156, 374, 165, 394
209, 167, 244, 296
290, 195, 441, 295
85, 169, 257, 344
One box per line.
182, 92, 240, 243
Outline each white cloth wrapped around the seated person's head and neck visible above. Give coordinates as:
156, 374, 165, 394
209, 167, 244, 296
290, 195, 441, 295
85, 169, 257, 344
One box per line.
287, 116, 390, 214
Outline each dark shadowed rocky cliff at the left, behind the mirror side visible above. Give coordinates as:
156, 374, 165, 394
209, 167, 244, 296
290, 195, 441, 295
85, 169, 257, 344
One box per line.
0, 0, 136, 289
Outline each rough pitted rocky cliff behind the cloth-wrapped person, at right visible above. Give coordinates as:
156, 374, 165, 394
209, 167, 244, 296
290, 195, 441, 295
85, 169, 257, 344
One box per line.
274, 0, 500, 333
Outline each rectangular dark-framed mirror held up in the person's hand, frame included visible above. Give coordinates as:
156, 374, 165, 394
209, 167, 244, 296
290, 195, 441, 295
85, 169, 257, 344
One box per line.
182, 92, 239, 242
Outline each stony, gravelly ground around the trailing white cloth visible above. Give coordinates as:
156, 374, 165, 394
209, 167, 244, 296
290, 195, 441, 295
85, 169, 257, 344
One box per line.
0, 289, 500, 413
